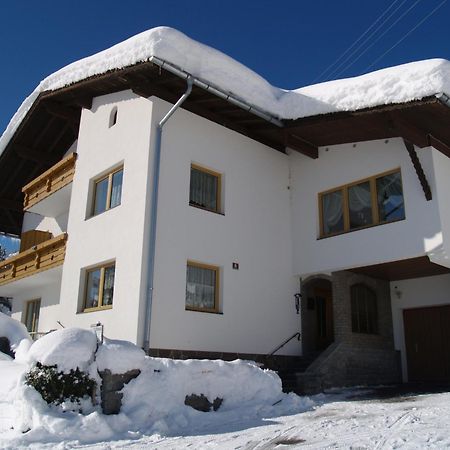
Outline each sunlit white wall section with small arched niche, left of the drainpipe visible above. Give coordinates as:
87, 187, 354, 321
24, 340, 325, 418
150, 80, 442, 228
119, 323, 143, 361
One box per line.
56, 91, 152, 342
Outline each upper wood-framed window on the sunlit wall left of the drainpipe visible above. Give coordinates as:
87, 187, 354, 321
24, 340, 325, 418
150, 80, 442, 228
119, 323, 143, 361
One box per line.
92, 167, 123, 216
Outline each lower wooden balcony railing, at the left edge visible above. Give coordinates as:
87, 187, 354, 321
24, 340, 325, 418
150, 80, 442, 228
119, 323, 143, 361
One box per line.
0, 233, 67, 286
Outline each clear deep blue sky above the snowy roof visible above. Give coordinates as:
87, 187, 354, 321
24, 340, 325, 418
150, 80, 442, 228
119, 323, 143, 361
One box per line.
0, 0, 450, 251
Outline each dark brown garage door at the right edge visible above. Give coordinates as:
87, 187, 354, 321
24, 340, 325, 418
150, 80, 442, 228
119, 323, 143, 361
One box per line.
403, 306, 450, 383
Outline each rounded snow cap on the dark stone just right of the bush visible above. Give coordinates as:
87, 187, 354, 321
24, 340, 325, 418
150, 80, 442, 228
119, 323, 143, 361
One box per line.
95, 338, 145, 374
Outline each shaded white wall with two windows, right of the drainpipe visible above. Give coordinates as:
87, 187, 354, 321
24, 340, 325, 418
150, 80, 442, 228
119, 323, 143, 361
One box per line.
150, 99, 300, 354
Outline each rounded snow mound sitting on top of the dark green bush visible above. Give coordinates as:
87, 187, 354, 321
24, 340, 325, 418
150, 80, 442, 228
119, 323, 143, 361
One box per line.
28, 328, 97, 373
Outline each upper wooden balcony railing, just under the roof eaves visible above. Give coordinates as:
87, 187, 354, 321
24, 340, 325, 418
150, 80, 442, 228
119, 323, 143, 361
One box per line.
22, 153, 77, 211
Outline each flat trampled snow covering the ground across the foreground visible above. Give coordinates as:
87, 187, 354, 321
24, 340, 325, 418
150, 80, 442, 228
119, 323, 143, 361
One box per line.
0, 354, 450, 450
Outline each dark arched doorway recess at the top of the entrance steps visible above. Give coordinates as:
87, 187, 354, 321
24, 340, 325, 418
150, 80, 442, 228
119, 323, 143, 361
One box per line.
301, 277, 334, 355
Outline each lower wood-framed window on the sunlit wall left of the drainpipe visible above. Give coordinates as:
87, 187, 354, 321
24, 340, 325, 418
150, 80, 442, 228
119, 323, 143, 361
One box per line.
83, 263, 116, 311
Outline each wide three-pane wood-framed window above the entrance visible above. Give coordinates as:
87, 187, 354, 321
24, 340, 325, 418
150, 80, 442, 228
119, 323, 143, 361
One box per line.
319, 169, 405, 237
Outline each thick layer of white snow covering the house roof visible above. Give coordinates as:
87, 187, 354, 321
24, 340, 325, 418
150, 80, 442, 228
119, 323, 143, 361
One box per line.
0, 27, 450, 154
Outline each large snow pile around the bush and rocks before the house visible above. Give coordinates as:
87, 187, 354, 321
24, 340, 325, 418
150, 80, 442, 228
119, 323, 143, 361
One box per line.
9, 329, 315, 447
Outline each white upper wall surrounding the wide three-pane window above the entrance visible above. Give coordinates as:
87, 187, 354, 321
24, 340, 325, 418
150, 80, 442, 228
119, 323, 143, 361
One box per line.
290, 138, 442, 275
